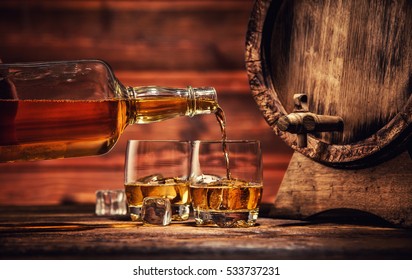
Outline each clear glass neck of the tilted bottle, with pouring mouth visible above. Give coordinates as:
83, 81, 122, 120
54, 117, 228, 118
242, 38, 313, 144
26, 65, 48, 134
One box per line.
126, 86, 219, 123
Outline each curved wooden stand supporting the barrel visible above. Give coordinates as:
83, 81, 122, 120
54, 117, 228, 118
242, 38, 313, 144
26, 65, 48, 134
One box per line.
272, 152, 412, 228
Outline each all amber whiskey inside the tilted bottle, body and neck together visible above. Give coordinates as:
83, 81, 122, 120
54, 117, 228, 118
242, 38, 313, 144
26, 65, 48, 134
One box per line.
0, 97, 217, 162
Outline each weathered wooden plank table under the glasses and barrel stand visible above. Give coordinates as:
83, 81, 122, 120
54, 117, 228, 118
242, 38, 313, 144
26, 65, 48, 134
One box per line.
0, 205, 412, 260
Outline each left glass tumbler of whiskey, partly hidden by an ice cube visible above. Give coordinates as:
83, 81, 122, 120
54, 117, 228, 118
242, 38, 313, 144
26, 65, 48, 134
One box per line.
124, 140, 191, 221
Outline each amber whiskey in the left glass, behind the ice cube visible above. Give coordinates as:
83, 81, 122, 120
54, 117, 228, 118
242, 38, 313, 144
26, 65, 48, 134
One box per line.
125, 178, 190, 221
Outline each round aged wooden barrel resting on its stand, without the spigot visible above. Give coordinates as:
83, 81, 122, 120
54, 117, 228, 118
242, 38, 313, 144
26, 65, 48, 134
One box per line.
246, 0, 412, 168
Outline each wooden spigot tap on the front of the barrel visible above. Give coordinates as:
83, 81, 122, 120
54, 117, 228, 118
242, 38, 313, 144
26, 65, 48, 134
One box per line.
277, 93, 343, 148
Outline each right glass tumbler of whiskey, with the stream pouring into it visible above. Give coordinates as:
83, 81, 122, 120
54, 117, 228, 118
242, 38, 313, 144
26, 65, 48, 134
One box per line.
190, 140, 263, 227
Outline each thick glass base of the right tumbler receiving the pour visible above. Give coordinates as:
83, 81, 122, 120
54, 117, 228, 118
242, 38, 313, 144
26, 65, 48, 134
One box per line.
194, 209, 259, 228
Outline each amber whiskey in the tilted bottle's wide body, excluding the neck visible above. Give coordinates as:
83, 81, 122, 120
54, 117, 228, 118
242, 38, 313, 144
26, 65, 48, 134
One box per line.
0, 100, 126, 162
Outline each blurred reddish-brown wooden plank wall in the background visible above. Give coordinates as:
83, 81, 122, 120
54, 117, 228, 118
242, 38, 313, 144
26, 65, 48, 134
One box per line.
0, 0, 291, 205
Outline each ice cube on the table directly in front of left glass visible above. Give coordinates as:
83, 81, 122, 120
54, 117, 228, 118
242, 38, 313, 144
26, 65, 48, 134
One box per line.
142, 197, 172, 226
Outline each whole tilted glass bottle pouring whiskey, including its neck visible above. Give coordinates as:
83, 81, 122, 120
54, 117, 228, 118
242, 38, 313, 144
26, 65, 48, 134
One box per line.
0, 60, 219, 162
